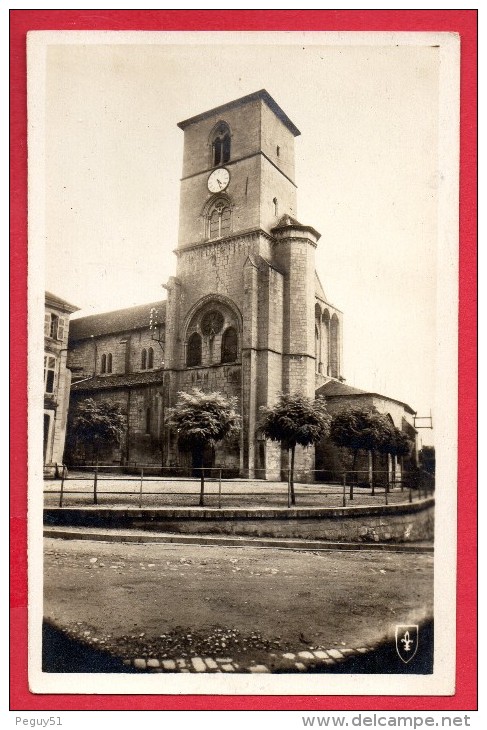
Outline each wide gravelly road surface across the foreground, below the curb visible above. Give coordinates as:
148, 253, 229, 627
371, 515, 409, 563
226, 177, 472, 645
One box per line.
44, 538, 433, 672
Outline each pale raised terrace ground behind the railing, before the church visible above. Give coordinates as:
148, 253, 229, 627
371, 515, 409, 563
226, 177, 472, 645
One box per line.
44, 473, 424, 507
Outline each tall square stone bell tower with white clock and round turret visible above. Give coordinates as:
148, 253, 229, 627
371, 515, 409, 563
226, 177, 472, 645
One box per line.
165, 90, 319, 479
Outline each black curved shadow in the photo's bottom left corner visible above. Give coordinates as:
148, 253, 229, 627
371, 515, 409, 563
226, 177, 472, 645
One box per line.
42, 621, 140, 674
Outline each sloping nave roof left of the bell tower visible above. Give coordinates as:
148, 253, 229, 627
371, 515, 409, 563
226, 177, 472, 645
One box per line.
69, 300, 166, 341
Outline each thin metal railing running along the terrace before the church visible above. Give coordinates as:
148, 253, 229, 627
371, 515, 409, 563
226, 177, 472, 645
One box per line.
44, 464, 434, 509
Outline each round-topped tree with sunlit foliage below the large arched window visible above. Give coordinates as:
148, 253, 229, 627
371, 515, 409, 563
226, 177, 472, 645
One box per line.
166, 388, 240, 507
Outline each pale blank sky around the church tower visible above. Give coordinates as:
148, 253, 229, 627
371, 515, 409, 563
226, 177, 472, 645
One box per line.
40, 33, 456, 443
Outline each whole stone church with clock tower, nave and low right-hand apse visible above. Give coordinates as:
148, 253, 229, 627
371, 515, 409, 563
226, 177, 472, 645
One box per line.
66, 90, 415, 480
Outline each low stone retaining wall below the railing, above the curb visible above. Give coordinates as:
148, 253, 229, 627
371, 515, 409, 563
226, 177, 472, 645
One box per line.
44, 497, 434, 544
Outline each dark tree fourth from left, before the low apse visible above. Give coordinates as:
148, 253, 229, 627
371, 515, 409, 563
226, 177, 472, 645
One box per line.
330, 408, 392, 489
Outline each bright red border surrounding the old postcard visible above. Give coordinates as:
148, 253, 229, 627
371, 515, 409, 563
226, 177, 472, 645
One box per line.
10, 10, 477, 711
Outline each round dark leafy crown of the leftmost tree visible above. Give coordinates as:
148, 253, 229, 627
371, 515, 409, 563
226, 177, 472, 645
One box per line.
70, 398, 126, 459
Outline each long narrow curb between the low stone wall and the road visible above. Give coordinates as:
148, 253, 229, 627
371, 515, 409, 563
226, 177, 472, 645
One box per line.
43, 527, 434, 553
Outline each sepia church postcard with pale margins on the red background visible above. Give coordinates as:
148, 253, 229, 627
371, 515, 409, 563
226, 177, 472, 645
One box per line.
27, 31, 459, 695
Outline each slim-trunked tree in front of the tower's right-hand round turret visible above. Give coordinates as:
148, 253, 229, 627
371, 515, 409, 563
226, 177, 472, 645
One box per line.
259, 393, 331, 504
